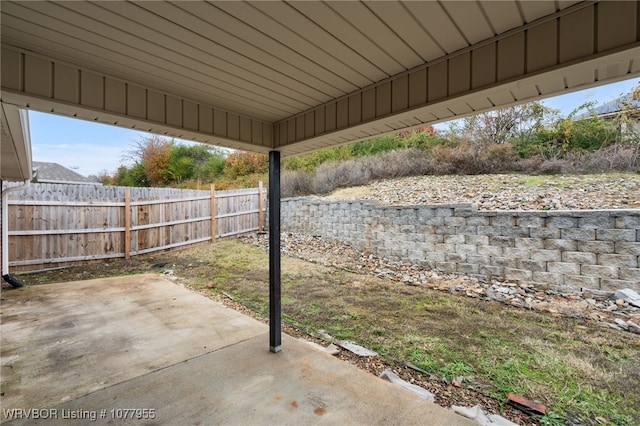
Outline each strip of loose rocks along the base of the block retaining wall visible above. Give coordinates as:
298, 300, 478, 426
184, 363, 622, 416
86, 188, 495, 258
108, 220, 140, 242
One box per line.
243, 233, 640, 334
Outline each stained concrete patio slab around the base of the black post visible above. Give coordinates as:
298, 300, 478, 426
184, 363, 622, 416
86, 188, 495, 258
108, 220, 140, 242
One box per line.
0, 275, 473, 425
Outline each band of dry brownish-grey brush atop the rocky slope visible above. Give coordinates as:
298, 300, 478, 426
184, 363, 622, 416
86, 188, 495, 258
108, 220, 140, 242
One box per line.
282, 144, 640, 197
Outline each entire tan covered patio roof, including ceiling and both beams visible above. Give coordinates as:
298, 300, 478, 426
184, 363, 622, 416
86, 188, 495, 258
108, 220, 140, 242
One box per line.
1, 0, 640, 179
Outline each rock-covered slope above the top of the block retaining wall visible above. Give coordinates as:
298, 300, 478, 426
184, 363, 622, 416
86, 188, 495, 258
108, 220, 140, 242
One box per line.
325, 173, 640, 210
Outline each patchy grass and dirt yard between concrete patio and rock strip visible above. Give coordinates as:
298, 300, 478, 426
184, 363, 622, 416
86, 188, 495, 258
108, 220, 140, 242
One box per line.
6, 239, 640, 425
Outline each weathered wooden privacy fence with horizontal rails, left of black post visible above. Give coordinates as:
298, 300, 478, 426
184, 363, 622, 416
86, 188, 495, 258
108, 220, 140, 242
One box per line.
7, 183, 266, 271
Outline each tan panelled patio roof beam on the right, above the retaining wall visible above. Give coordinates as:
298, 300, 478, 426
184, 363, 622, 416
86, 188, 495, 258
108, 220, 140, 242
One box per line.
274, 2, 640, 154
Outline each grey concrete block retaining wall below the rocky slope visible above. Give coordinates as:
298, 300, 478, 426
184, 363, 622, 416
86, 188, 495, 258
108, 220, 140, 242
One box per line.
282, 198, 640, 291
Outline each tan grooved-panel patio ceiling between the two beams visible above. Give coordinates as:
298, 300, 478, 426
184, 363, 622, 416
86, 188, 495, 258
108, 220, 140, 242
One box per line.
1, 1, 579, 122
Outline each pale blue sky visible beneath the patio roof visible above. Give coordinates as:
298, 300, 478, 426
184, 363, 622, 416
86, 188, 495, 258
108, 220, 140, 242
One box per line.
29, 78, 640, 176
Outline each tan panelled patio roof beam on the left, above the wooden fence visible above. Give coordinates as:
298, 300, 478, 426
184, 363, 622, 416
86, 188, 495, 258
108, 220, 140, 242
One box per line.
1, 44, 273, 152
